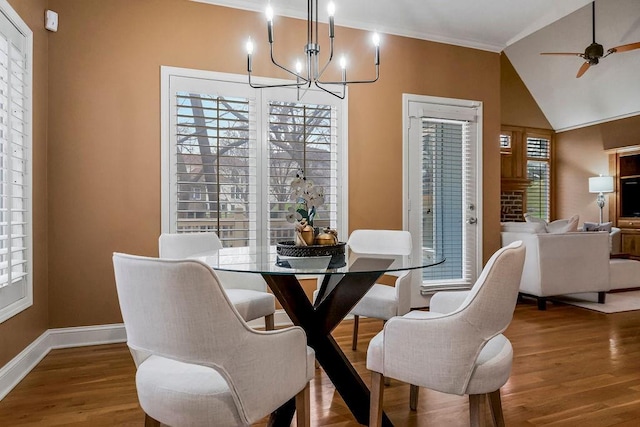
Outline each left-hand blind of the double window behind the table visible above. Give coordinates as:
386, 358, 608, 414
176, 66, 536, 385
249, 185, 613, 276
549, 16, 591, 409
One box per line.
174, 91, 256, 246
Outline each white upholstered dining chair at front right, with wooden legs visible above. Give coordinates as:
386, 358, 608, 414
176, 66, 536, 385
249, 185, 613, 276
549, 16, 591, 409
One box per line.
367, 241, 525, 426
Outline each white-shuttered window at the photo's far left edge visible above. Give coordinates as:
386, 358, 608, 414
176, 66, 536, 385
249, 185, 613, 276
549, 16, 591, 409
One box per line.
0, 0, 33, 322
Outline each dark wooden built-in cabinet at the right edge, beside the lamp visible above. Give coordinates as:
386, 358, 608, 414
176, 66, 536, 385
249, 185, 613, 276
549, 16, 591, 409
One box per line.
611, 147, 640, 256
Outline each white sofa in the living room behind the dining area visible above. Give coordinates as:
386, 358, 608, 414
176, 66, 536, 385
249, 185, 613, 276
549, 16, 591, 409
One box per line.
501, 231, 608, 310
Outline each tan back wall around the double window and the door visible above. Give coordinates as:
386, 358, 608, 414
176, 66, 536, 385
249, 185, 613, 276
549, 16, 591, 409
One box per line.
40, 0, 500, 327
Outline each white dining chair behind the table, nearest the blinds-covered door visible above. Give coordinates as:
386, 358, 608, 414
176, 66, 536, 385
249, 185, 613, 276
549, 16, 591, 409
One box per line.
347, 230, 412, 351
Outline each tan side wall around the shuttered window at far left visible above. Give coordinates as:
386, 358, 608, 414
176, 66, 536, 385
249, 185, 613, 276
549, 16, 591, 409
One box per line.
0, 0, 48, 367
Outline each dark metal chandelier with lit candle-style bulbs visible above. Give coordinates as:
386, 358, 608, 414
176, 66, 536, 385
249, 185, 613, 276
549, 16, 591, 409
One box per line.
247, 0, 380, 100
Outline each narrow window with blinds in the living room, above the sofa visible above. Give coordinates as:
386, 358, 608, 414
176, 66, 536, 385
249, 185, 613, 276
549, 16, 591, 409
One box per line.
526, 134, 551, 221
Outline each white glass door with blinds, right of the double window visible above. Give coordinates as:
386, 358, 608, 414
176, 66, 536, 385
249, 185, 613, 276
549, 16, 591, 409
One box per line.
404, 95, 482, 307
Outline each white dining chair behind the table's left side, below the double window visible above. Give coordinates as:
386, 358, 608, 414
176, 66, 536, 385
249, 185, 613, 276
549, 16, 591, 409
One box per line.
158, 232, 276, 330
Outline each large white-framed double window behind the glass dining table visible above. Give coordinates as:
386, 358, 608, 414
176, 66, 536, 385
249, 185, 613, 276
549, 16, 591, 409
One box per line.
162, 67, 347, 252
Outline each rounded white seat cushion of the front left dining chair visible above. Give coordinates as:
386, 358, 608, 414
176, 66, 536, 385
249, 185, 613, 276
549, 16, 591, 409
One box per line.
136, 356, 245, 426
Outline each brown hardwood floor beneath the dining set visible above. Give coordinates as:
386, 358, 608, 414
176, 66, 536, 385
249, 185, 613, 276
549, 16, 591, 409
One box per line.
0, 300, 640, 427
